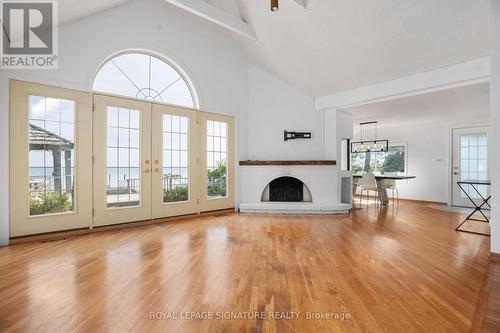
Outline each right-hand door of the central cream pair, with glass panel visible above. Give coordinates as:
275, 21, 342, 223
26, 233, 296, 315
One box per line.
152, 104, 198, 218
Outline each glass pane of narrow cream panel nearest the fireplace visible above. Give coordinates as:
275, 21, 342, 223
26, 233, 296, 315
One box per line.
207, 120, 227, 199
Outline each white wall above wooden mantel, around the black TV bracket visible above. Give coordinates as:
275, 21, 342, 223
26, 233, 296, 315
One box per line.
248, 65, 324, 160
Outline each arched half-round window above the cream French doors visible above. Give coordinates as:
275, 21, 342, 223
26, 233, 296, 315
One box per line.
93, 53, 197, 108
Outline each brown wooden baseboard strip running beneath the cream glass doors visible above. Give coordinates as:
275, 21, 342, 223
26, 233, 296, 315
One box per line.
9, 207, 235, 245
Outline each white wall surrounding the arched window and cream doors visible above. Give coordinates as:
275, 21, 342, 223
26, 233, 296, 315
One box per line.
0, 0, 250, 244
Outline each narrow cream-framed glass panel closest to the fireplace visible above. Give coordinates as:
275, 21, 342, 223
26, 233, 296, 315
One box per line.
199, 112, 234, 212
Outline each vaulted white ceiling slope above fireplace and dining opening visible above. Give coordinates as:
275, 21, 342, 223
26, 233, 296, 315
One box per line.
210, 0, 489, 97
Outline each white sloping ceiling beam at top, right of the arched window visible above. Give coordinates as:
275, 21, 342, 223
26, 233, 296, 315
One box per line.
165, 0, 257, 41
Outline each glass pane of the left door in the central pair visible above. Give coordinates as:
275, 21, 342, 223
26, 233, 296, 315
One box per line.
106, 106, 141, 207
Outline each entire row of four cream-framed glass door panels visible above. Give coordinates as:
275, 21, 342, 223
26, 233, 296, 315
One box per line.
10, 81, 234, 237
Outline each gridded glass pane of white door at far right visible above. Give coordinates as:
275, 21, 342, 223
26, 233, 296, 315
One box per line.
460, 133, 488, 199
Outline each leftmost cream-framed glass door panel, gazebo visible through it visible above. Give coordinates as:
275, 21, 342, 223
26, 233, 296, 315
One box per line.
9, 80, 92, 237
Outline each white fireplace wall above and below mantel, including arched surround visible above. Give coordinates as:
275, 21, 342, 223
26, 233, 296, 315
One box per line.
240, 65, 338, 204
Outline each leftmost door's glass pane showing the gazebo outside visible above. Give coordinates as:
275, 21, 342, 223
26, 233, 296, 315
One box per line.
28, 96, 75, 216
